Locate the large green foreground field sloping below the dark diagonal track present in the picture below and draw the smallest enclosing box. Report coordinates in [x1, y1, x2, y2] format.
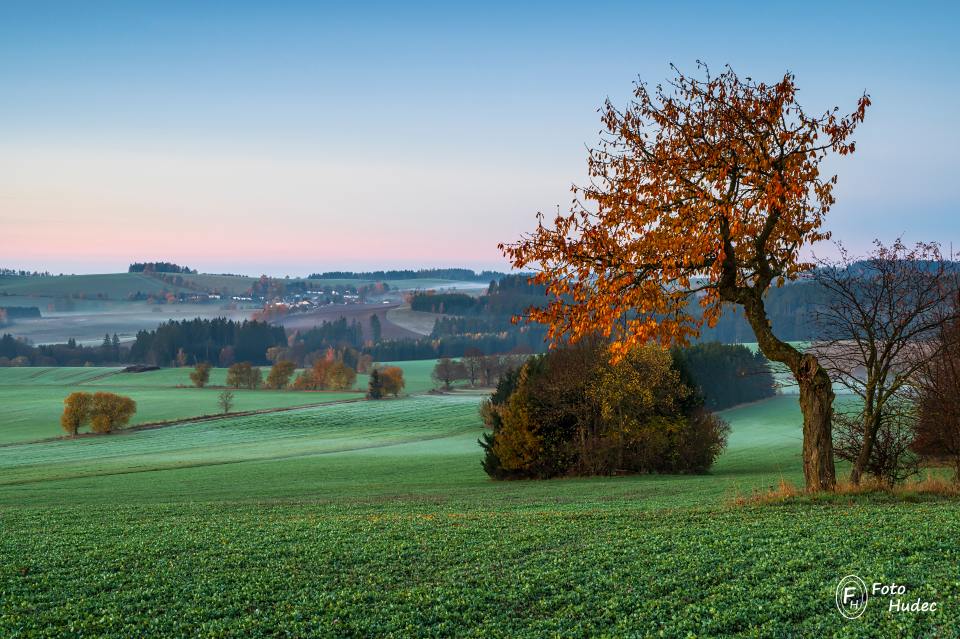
[0, 394, 960, 637]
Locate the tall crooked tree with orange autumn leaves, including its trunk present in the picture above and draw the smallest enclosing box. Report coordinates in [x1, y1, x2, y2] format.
[500, 64, 870, 490]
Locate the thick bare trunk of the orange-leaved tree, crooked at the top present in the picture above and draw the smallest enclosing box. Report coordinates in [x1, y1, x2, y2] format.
[741, 297, 837, 492]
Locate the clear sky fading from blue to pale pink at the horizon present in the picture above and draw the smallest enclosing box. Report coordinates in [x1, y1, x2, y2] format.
[0, 0, 960, 276]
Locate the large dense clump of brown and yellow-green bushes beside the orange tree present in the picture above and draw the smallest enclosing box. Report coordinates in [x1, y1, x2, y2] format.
[480, 342, 729, 479]
